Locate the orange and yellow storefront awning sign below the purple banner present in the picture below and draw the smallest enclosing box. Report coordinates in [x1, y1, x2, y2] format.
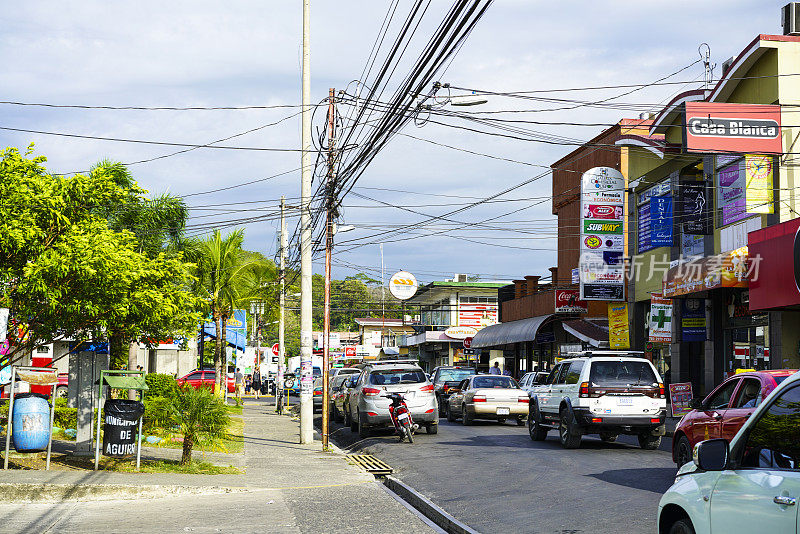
[663, 247, 750, 298]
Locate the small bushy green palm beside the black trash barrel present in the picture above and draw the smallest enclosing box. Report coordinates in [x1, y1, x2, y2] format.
[169, 384, 230, 465]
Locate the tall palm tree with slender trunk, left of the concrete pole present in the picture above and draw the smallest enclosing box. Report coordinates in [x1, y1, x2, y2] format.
[187, 230, 258, 395]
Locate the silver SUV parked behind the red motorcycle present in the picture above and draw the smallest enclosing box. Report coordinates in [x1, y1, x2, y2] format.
[345, 361, 439, 438]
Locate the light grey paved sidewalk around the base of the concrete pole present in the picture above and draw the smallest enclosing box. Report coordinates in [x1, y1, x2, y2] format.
[0, 402, 431, 534]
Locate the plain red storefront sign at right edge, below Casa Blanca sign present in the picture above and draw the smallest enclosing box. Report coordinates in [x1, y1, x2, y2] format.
[747, 219, 800, 311]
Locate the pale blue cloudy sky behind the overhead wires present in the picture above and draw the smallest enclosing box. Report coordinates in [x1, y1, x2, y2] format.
[0, 0, 786, 282]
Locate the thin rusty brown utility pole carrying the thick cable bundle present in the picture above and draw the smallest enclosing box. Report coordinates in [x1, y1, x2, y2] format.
[322, 88, 336, 451]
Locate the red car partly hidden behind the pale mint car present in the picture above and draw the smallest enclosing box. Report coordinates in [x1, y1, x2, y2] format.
[672, 369, 797, 467]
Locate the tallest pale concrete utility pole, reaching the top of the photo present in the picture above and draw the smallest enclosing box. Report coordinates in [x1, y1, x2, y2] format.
[300, 0, 314, 444]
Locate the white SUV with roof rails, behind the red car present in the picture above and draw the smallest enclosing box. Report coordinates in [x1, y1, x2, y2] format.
[528, 351, 667, 450]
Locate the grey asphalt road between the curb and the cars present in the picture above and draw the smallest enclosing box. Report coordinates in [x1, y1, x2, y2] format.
[317, 418, 676, 534]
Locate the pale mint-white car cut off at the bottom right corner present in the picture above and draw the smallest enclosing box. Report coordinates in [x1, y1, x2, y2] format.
[658, 373, 800, 534]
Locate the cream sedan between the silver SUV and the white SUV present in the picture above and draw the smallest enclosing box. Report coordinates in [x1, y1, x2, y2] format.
[447, 375, 528, 426]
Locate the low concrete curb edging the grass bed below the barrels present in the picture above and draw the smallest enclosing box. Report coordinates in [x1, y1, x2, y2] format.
[0, 482, 248, 504]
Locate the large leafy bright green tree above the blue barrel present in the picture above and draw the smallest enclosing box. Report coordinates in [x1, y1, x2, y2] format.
[0, 147, 197, 363]
